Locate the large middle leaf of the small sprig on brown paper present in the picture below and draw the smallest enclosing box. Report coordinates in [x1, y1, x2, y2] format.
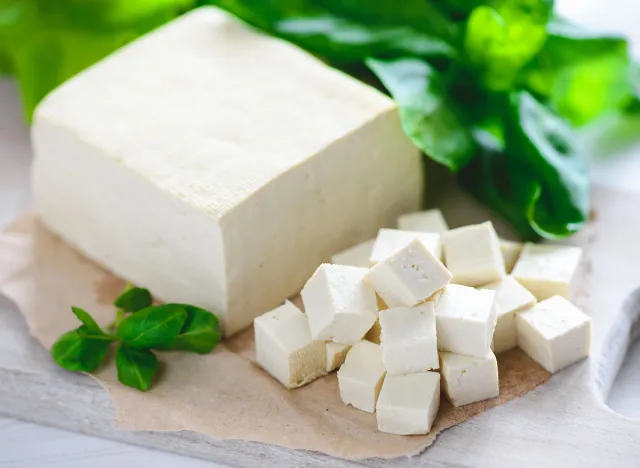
[117, 304, 187, 349]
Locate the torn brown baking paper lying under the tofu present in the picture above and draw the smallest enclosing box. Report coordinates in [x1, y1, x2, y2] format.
[0, 215, 549, 459]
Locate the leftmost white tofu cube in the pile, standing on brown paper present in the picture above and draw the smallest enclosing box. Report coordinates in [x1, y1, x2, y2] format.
[253, 301, 327, 388]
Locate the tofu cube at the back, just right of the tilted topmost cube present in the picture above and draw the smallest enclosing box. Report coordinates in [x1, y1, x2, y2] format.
[442, 221, 505, 287]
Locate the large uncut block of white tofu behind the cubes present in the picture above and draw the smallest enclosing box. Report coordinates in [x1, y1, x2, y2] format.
[32, 7, 422, 334]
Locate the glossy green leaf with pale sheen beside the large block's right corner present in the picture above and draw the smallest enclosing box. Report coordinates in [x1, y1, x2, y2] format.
[367, 58, 475, 171]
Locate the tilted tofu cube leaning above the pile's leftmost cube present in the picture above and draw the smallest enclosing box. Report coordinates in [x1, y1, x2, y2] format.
[300, 263, 378, 344]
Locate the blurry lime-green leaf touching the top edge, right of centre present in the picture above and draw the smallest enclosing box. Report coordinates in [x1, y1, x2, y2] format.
[464, 0, 553, 91]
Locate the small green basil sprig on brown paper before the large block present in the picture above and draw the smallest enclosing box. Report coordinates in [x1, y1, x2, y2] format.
[51, 285, 222, 391]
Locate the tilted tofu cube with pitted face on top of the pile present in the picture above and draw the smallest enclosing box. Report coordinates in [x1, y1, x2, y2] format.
[366, 239, 452, 307]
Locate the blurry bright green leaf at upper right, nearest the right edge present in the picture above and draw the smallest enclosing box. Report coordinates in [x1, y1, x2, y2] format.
[520, 21, 634, 125]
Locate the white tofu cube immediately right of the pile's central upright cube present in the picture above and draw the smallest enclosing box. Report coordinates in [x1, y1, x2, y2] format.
[436, 284, 496, 358]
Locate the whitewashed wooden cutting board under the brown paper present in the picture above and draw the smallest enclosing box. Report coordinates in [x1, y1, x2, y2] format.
[0, 176, 640, 467]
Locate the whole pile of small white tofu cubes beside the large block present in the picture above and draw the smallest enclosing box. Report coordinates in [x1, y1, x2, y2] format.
[254, 210, 590, 434]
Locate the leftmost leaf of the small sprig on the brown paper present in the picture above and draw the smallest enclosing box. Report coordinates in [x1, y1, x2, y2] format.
[51, 327, 111, 372]
